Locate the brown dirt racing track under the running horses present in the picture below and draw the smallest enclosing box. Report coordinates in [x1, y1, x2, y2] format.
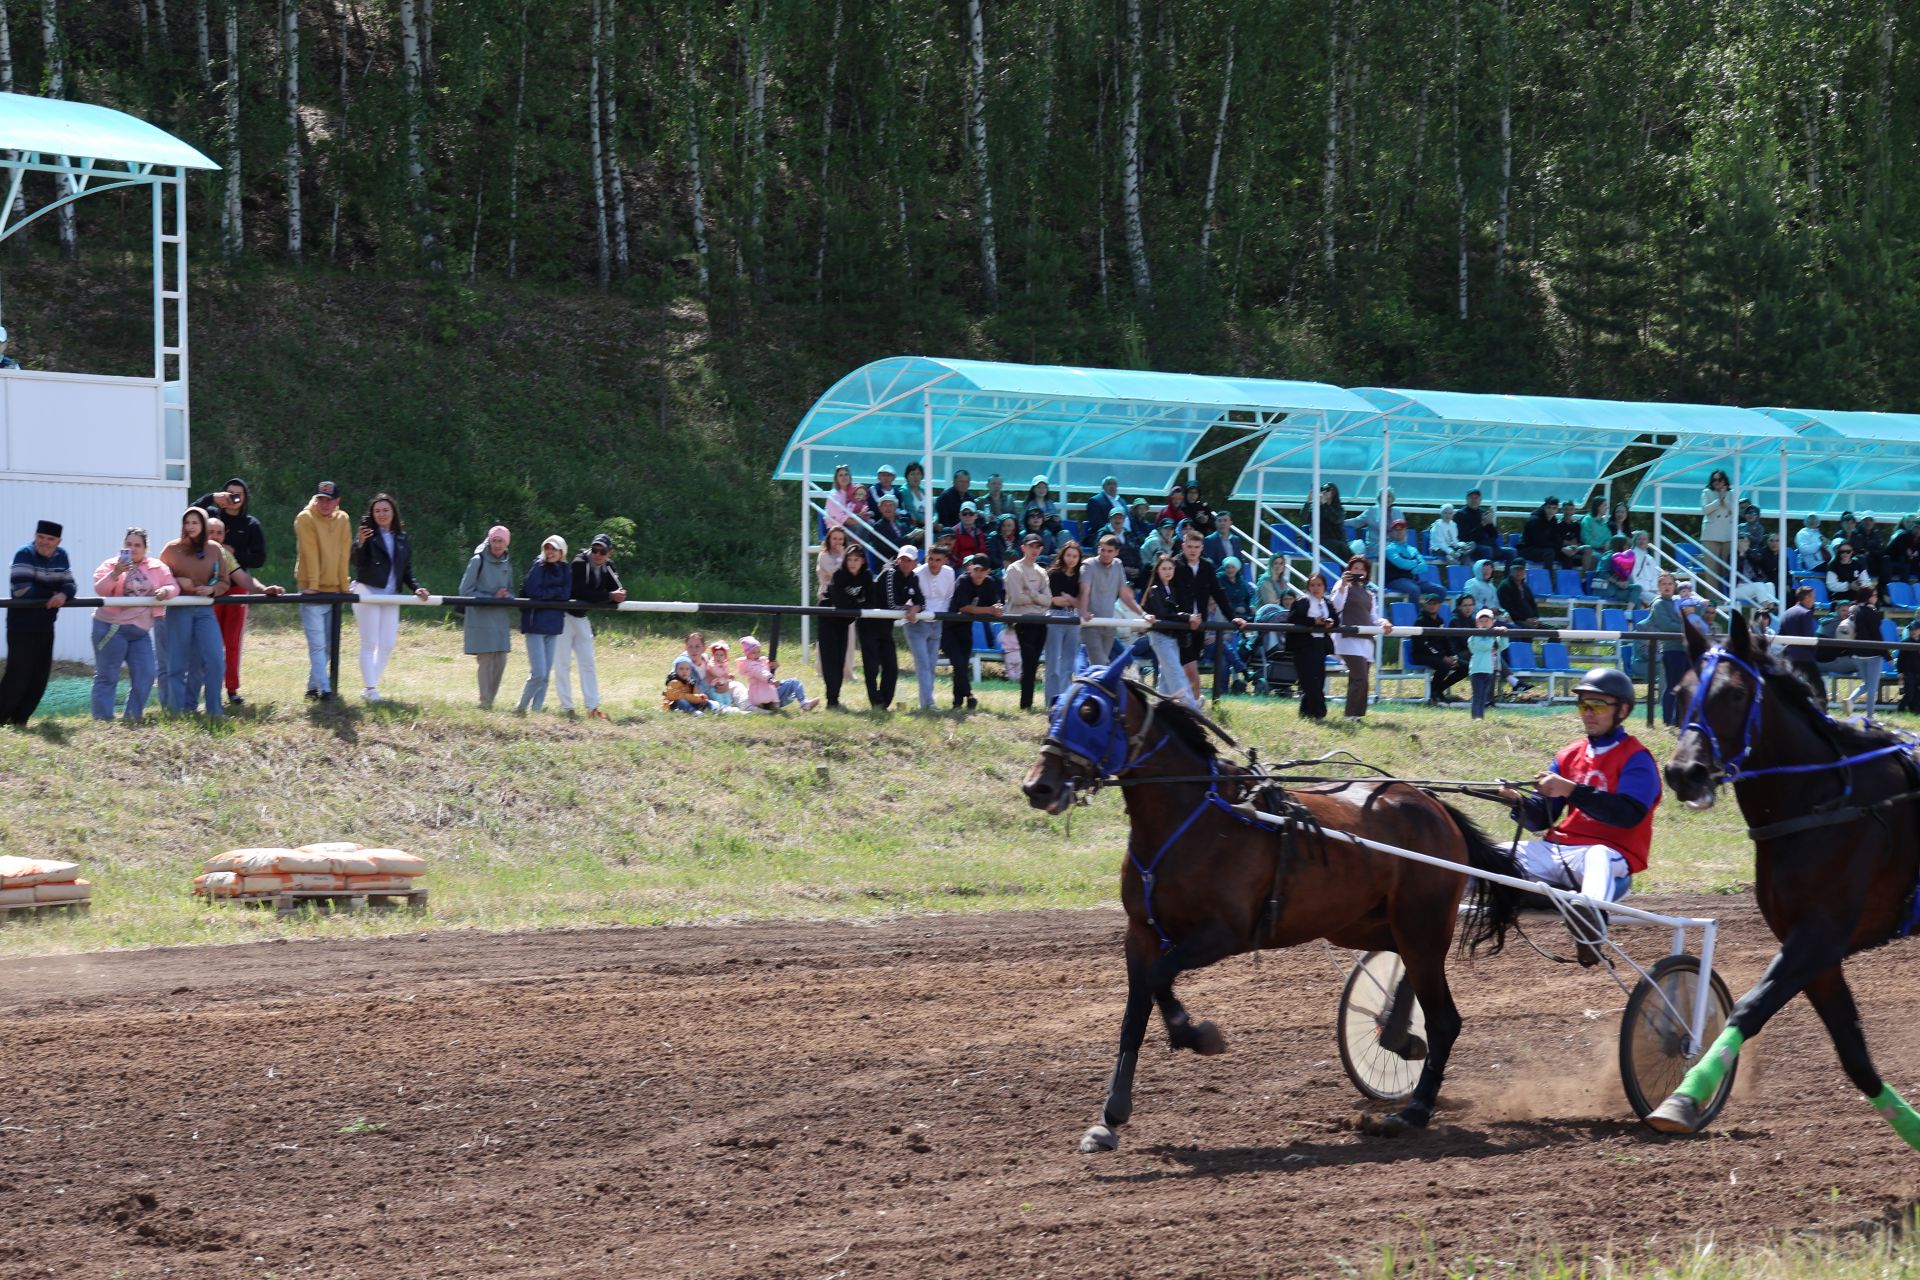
[0, 898, 1920, 1278]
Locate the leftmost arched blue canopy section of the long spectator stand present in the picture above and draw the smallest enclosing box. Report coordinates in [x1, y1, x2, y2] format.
[774, 355, 1369, 497]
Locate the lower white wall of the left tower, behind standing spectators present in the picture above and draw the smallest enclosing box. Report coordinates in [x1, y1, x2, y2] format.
[0, 474, 192, 664]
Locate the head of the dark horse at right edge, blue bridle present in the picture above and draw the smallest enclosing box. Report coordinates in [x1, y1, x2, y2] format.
[1667, 612, 1766, 810]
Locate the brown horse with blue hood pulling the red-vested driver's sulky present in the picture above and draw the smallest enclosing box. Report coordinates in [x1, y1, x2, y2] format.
[1023, 656, 1526, 1151]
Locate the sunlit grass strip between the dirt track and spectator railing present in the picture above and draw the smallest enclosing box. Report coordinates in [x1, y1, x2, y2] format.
[0, 610, 1774, 954]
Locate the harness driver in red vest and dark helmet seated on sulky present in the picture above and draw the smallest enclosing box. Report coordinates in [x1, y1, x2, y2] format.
[1500, 666, 1661, 948]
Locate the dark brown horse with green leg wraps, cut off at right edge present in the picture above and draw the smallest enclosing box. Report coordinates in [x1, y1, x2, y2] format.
[1647, 614, 1920, 1148]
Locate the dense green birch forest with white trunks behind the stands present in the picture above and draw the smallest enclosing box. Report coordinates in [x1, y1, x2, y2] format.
[0, 0, 1920, 411]
